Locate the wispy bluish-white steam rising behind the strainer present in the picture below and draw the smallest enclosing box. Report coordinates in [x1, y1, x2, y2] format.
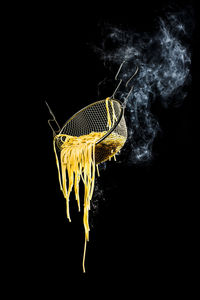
[95, 11, 193, 163]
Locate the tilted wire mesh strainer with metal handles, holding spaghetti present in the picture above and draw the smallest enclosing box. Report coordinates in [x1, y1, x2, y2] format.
[47, 61, 138, 164]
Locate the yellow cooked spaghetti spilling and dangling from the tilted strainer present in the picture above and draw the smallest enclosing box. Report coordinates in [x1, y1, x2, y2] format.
[53, 98, 126, 272]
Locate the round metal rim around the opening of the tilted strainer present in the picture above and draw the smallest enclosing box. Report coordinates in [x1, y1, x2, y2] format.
[60, 99, 125, 145]
